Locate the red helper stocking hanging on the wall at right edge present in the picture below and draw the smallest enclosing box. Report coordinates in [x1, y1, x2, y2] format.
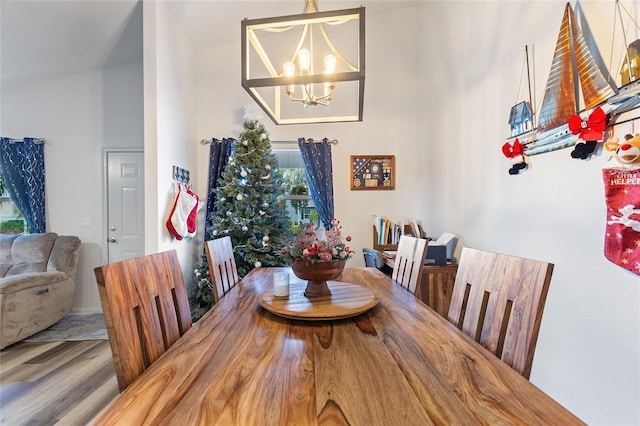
[602, 169, 640, 275]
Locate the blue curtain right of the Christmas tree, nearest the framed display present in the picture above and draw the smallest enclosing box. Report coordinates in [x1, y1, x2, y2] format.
[298, 138, 333, 229]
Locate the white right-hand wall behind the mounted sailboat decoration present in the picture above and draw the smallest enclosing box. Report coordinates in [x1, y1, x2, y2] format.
[417, 1, 640, 425]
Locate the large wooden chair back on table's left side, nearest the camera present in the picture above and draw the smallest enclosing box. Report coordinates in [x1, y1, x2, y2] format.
[94, 250, 191, 392]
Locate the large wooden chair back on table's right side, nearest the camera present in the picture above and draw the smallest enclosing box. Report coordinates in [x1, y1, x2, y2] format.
[448, 247, 553, 379]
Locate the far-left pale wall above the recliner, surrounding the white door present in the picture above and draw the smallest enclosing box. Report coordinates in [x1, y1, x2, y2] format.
[0, 62, 142, 313]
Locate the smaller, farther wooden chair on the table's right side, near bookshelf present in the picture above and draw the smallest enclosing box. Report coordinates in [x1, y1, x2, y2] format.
[391, 235, 427, 294]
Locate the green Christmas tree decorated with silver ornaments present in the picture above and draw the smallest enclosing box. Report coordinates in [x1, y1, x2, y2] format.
[210, 119, 289, 277]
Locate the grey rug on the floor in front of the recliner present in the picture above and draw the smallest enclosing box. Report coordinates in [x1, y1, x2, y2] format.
[24, 314, 109, 342]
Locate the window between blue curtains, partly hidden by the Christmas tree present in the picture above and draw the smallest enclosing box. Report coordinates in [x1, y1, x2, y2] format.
[273, 150, 319, 226]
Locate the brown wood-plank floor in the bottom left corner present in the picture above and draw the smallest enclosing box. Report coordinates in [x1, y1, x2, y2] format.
[0, 340, 118, 426]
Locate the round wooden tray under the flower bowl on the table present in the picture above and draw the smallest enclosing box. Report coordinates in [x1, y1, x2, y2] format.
[260, 281, 378, 321]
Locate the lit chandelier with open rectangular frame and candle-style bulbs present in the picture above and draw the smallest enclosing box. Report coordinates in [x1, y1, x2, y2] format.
[242, 0, 365, 124]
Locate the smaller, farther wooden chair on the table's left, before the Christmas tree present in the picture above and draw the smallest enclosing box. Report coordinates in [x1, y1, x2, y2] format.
[204, 237, 240, 302]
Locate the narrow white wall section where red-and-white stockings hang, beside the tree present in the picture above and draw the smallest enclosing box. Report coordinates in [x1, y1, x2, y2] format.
[143, 2, 199, 286]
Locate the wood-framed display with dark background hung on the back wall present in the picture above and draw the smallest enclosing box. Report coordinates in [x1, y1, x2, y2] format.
[351, 155, 396, 190]
